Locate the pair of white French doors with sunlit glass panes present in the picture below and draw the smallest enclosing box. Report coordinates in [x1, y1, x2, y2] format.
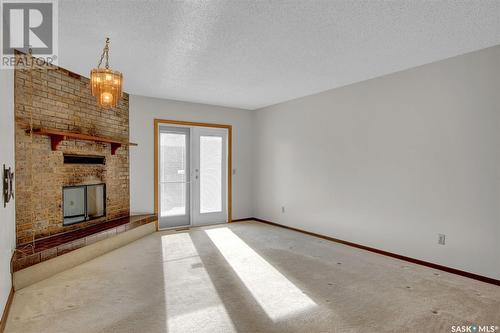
[156, 123, 228, 229]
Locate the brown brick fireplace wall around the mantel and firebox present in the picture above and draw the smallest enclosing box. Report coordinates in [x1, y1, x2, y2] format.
[15, 63, 130, 245]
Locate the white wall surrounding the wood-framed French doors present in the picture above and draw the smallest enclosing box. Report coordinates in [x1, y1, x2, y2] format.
[130, 95, 253, 219]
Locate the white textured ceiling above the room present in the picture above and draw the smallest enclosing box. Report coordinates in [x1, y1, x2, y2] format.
[59, 0, 500, 109]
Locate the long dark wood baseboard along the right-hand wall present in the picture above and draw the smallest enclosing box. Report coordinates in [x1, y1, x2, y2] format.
[253, 217, 500, 286]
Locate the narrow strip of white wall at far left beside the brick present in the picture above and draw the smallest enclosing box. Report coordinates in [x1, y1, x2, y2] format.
[0, 70, 16, 316]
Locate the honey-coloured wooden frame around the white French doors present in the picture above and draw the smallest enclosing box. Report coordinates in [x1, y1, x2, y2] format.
[154, 118, 233, 231]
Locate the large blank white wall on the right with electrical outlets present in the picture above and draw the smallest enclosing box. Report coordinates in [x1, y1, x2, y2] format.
[254, 47, 500, 279]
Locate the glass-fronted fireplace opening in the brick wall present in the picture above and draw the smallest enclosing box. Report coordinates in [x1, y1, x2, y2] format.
[63, 184, 106, 225]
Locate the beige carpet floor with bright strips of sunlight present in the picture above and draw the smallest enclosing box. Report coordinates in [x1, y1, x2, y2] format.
[6, 222, 500, 333]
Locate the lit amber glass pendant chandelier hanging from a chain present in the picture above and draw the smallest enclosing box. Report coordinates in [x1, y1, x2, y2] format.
[90, 38, 123, 108]
